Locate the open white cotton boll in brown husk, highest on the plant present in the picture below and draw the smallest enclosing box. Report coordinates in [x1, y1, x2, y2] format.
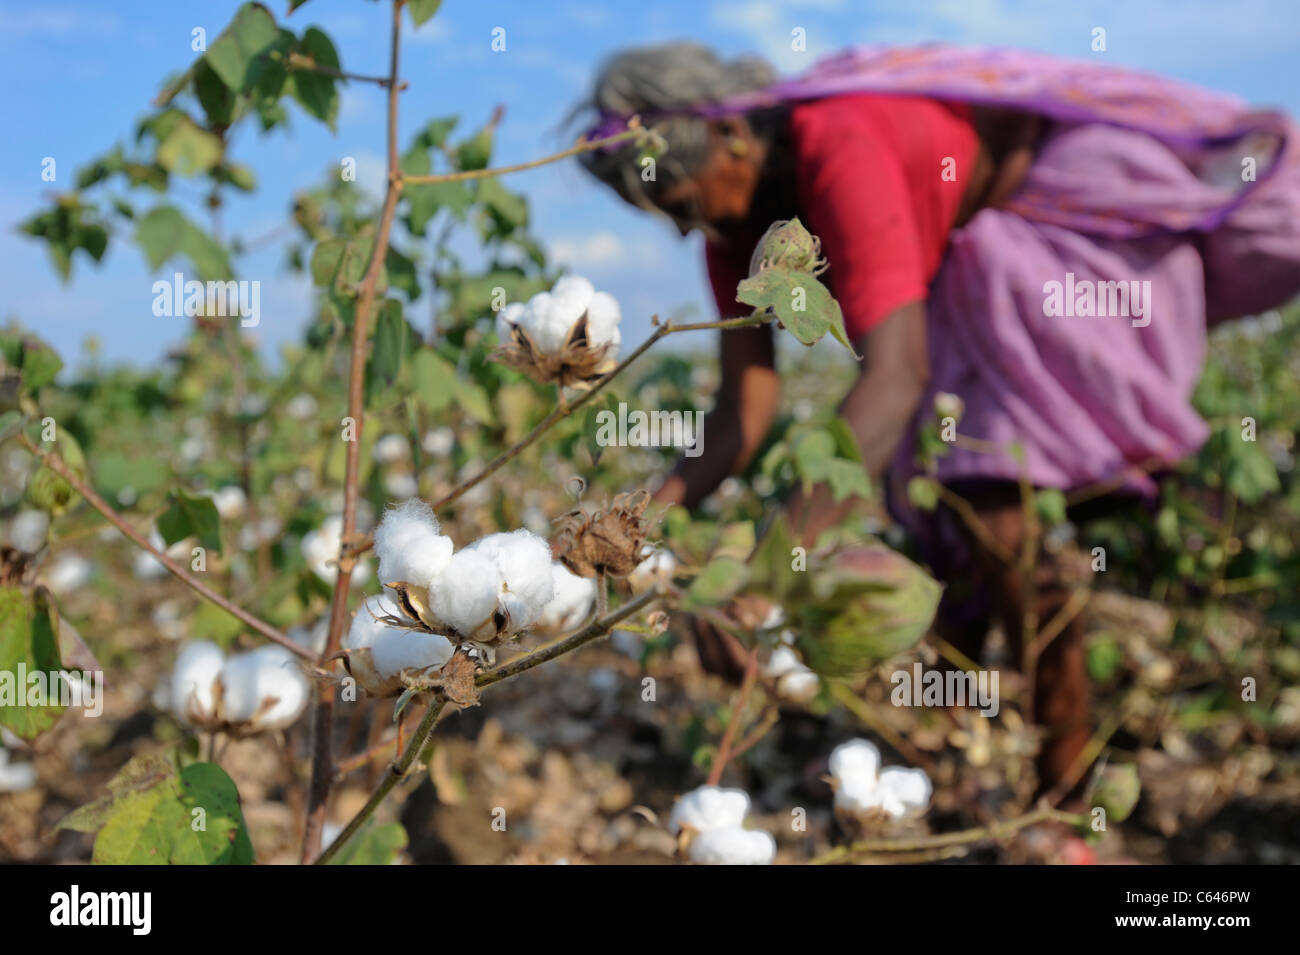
[495, 275, 623, 388]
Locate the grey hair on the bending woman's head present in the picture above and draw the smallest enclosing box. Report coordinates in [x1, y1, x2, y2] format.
[571, 43, 776, 218]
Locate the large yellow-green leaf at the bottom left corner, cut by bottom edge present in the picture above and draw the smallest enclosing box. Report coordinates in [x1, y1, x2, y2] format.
[91, 763, 254, 865]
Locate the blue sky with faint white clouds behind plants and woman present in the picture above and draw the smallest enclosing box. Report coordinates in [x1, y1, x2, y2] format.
[0, 0, 1300, 363]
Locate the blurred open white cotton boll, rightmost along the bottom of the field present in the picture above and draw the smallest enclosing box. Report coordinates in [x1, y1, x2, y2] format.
[829, 739, 933, 828]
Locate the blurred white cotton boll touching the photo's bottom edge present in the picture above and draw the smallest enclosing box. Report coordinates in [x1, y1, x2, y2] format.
[668, 786, 776, 865]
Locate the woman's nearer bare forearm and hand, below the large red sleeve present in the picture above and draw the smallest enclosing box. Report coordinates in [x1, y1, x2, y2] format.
[788, 301, 930, 546]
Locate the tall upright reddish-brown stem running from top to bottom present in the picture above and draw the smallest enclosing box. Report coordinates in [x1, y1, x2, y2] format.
[302, 0, 403, 863]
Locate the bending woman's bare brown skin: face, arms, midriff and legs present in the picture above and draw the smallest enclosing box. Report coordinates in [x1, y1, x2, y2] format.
[639, 109, 1089, 791]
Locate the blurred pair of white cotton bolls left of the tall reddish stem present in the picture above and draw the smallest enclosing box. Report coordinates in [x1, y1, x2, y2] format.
[163, 641, 311, 737]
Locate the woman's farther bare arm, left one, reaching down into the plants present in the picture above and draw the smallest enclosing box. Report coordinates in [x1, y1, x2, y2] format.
[654, 325, 781, 508]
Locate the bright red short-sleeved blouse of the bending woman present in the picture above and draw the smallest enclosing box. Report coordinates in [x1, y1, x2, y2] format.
[705, 94, 979, 338]
